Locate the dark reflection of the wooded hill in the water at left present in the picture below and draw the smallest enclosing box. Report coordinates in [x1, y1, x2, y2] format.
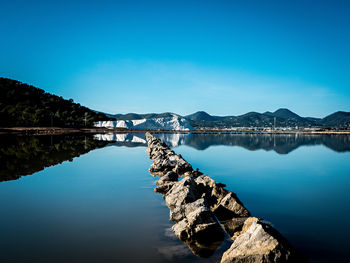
[0, 135, 107, 182]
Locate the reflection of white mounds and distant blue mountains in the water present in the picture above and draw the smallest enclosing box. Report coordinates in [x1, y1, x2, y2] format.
[95, 133, 350, 154]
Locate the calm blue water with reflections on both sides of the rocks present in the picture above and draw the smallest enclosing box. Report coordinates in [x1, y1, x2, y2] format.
[0, 133, 350, 263]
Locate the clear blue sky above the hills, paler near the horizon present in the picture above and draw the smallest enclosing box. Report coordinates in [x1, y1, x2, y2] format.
[0, 0, 350, 117]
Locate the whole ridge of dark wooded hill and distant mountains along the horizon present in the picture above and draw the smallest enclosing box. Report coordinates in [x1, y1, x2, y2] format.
[0, 77, 350, 129]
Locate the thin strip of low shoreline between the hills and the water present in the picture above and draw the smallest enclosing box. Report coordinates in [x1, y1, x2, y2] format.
[0, 127, 350, 135]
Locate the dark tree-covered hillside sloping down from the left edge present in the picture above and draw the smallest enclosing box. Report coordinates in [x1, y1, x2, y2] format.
[0, 78, 110, 127]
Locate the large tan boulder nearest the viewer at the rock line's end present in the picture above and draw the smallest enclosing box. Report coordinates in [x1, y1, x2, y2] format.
[221, 217, 305, 263]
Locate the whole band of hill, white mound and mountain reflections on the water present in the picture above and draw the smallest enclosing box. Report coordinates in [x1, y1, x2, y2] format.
[0, 133, 350, 182]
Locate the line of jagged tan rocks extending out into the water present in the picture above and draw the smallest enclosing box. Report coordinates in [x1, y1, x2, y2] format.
[146, 133, 305, 263]
